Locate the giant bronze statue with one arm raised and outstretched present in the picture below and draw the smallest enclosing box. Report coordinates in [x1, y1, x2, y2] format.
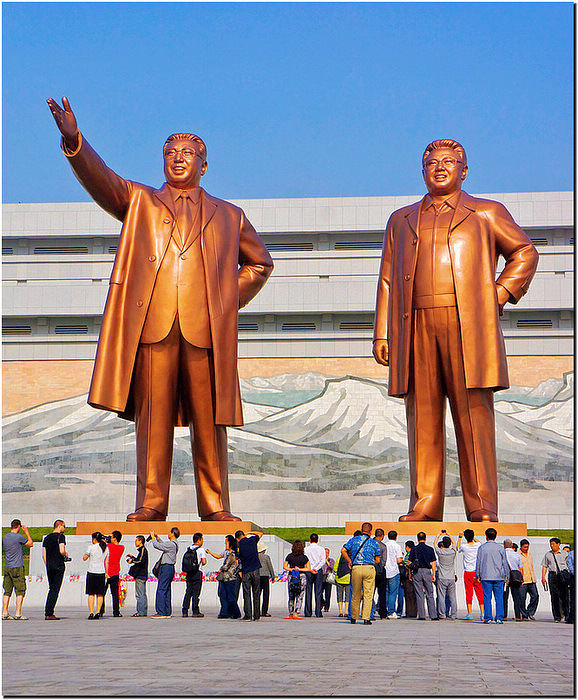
[48, 97, 273, 521]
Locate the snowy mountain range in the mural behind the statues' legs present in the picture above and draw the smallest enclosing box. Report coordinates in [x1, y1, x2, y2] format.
[3, 373, 574, 509]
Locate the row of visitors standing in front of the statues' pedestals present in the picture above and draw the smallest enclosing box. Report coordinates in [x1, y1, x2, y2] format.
[2, 519, 574, 625]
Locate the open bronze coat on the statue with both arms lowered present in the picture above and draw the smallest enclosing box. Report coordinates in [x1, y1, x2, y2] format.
[374, 192, 538, 396]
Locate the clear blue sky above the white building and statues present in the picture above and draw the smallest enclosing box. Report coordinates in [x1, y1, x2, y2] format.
[2, 2, 573, 202]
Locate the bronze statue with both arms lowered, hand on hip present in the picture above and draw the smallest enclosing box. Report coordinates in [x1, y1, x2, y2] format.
[373, 139, 538, 522]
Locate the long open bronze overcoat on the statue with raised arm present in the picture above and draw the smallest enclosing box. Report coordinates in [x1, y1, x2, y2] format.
[63, 136, 273, 425]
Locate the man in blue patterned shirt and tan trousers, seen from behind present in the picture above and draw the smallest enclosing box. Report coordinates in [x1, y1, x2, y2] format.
[341, 523, 381, 625]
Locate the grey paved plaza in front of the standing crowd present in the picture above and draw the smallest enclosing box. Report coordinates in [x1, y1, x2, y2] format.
[2, 599, 574, 697]
